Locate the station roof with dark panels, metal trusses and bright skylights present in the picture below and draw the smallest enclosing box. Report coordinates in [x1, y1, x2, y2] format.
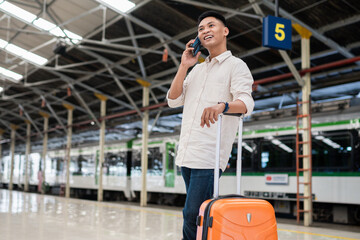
[0, 0, 360, 147]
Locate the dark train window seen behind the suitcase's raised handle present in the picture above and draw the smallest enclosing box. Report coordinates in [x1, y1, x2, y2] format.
[226, 141, 256, 173]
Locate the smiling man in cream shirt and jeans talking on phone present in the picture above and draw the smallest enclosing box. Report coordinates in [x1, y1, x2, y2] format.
[167, 11, 254, 240]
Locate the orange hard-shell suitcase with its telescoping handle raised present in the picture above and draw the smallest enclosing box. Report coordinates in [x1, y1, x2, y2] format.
[196, 114, 278, 240]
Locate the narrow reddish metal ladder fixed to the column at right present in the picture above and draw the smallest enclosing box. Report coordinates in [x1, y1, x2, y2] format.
[296, 100, 312, 223]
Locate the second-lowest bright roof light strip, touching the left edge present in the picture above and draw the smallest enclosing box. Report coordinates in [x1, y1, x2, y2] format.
[0, 39, 48, 66]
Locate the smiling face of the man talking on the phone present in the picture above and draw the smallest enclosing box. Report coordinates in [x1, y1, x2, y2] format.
[198, 17, 229, 48]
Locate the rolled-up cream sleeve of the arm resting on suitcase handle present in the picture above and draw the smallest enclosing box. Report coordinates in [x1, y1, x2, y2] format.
[230, 59, 255, 116]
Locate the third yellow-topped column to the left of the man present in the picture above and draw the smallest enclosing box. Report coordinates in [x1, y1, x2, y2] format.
[63, 103, 74, 198]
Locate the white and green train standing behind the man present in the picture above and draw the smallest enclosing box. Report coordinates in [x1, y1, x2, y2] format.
[0, 109, 360, 224]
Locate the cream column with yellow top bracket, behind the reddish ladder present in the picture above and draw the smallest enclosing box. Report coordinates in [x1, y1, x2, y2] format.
[293, 24, 312, 226]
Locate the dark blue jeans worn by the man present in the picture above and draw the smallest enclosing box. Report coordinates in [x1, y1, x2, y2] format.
[181, 167, 222, 240]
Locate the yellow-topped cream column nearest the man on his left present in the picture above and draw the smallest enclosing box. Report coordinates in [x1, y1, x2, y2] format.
[140, 82, 150, 207]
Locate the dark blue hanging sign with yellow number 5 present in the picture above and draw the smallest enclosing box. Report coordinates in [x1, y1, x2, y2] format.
[263, 16, 292, 50]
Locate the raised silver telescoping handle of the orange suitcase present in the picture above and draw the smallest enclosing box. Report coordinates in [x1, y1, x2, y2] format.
[214, 113, 244, 198]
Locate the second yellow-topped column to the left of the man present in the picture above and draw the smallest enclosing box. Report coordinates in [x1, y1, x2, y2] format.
[95, 93, 107, 202]
